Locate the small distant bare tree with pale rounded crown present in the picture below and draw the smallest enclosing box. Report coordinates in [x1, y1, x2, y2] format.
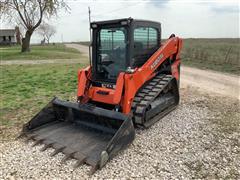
[38, 23, 57, 44]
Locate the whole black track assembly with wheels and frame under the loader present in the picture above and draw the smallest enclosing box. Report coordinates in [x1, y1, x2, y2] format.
[132, 74, 179, 127]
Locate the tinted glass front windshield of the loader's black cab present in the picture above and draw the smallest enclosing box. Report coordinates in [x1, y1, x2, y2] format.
[96, 27, 127, 80]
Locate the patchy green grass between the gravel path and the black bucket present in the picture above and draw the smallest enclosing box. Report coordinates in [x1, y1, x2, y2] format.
[0, 64, 85, 132]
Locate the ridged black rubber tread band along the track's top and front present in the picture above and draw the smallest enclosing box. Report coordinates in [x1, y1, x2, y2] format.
[132, 74, 173, 126]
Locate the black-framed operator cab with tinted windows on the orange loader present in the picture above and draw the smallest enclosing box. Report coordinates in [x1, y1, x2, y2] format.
[91, 18, 161, 84]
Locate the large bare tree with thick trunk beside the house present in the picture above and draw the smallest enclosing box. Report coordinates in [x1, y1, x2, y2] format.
[0, 0, 69, 52]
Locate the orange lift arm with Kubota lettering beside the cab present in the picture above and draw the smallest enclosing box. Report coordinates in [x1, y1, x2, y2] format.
[122, 37, 182, 114]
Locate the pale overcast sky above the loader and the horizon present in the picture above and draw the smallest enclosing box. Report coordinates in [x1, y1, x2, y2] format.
[1, 0, 240, 42]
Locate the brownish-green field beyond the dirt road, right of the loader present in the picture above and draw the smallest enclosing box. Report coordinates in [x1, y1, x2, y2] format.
[80, 38, 240, 75]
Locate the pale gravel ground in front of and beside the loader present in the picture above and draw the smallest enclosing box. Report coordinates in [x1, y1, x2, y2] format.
[0, 88, 240, 179]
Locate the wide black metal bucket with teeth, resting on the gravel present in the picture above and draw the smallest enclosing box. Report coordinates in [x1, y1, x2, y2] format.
[21, 98, 135, 171]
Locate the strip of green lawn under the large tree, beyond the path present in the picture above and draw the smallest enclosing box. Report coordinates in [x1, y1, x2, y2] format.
[0, 44, 81, 61]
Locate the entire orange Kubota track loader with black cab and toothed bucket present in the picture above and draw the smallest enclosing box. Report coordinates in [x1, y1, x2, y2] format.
[21, 18, 182, 172]
